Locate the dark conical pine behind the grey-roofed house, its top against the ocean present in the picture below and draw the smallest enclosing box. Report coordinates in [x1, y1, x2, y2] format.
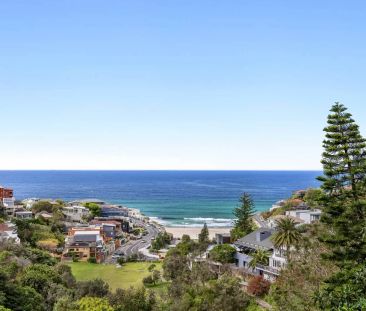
[231, 192, 254, 240]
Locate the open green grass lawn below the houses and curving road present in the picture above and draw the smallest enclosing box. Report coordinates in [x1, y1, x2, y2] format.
[69, 262, 161, 291]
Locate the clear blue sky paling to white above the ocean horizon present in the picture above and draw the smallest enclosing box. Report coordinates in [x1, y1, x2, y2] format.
[0, 0, 366, 169]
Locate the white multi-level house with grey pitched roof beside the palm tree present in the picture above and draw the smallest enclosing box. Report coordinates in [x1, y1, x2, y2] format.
[234, 228, 286, 281]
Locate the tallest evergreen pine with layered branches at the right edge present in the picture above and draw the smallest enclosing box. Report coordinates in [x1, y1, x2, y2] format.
[317, 103, 366, 310]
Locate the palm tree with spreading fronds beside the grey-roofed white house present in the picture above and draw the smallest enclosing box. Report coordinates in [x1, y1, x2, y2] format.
[272, 217, 301, 258]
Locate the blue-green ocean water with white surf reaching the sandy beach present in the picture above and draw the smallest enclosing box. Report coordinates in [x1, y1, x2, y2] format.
[0, 171, 321, 226]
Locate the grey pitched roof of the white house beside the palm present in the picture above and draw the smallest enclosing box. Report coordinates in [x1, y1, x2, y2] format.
[234, 228, 275, 250]
